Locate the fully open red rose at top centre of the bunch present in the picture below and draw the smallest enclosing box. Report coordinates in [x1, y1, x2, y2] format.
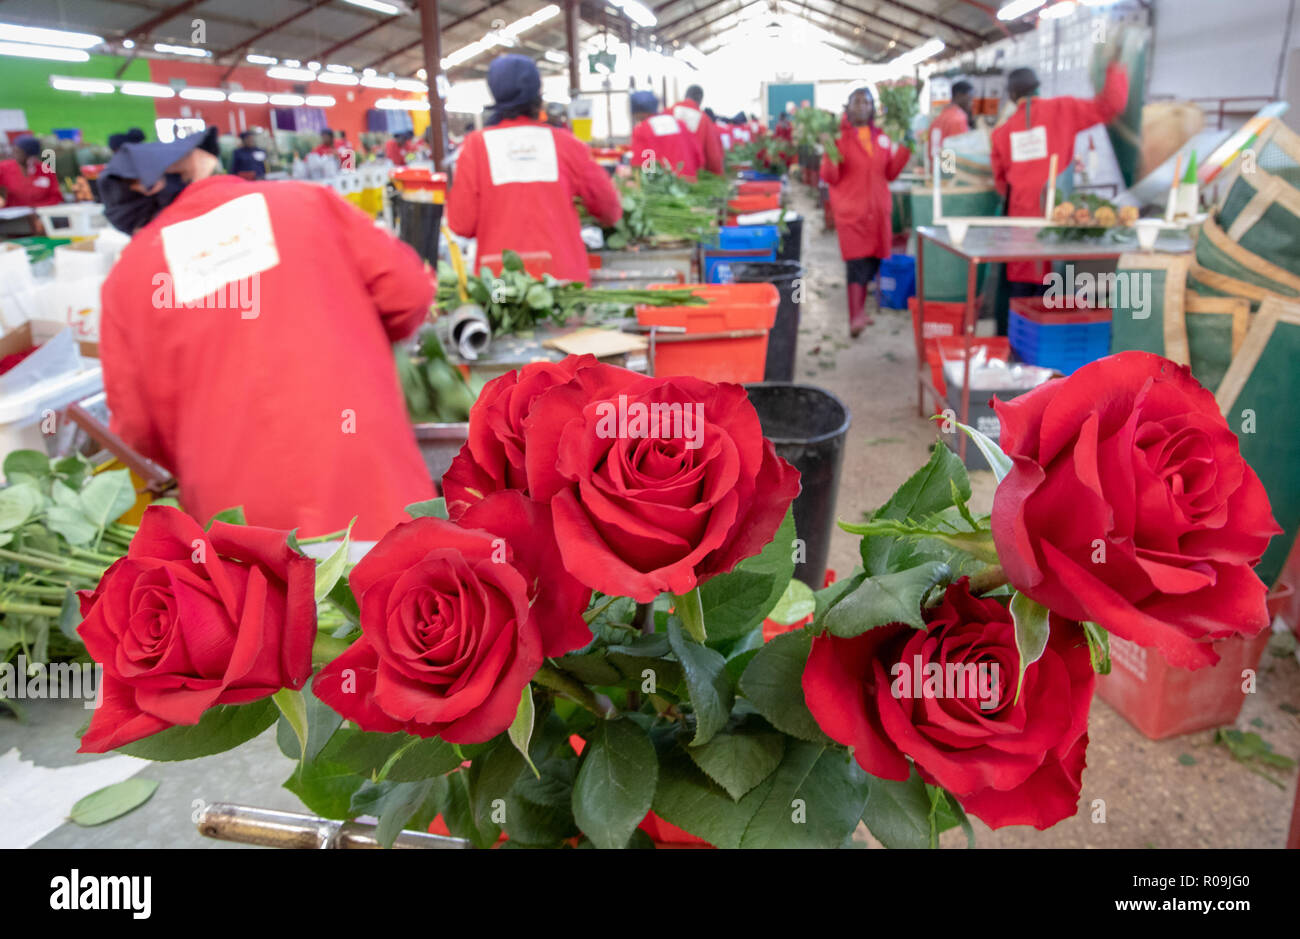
[524, 367, 800, 602]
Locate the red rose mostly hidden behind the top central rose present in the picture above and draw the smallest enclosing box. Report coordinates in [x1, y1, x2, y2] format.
[442, 355, 597, 519]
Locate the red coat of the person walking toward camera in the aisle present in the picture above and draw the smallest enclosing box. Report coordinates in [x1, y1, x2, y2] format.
[820, 116, 911, 260]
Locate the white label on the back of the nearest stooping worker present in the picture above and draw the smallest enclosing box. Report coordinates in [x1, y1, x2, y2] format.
[161, 192, 280, 304]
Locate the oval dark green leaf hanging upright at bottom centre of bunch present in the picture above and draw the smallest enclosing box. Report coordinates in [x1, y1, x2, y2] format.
[573, 717, 655, 848]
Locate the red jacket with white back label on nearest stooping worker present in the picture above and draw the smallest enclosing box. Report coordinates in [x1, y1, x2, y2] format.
[100, 176, 434, 540]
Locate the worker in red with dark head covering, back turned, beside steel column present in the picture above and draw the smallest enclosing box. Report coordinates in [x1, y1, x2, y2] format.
[447, 53, 623, 284]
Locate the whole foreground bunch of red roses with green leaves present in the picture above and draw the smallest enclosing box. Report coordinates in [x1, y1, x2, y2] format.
[79, 352, 1278, 848]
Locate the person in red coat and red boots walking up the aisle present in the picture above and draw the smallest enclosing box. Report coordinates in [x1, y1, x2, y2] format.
[820, 88, 911, 337]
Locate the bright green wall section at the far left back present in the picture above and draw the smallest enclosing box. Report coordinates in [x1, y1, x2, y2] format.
[0, 55, 156, 146]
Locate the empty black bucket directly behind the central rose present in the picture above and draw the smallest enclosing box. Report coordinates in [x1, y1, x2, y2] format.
[745, 382, 850, 590]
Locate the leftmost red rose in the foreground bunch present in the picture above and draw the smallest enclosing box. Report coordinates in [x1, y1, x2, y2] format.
[77, 506, 316, 753]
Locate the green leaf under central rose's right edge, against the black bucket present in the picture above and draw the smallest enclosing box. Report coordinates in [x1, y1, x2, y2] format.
[699, 510, 796, 642]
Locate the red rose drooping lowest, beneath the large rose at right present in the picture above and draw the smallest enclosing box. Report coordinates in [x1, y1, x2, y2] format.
[803, 577, 1096, 828]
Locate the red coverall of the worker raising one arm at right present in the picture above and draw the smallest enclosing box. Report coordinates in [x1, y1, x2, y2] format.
[993, 62, 1128, 284]
